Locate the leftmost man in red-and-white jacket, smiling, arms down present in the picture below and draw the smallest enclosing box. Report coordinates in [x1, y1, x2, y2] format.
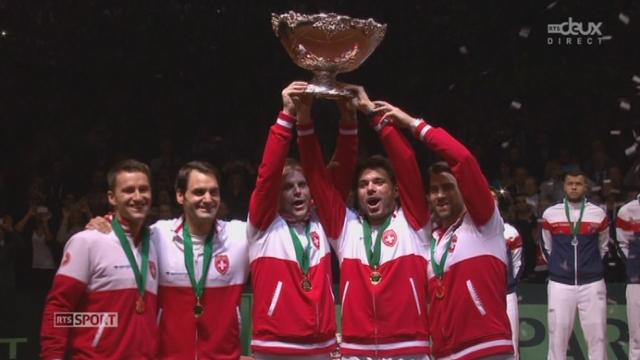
[40, 160, 158, 360]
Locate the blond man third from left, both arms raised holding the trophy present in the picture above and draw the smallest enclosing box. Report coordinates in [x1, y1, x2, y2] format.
[247, 81, 357, 359]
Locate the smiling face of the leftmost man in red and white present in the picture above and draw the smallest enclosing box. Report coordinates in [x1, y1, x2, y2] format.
[107, 171, 151, 223]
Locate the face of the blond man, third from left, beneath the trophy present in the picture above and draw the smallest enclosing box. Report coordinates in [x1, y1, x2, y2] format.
[278, 167, 311, 221]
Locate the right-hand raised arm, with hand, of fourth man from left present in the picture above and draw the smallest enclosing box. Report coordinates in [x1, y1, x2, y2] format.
[349, 90, 429, 230]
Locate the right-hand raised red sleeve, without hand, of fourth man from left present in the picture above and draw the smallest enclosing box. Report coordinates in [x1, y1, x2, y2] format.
[372, 115, 429, 230]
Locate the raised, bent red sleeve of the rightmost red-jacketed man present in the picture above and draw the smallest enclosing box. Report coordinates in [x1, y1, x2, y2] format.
[415, 123, 495, 226]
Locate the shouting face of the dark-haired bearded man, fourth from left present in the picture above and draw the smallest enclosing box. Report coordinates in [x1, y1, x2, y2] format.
[358, 168, 398, 225]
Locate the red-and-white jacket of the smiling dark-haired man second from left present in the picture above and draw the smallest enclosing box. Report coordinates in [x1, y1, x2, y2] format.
[151, 217, 249, 360]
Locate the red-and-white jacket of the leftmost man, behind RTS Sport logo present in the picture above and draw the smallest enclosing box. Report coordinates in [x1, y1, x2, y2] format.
[40, 230, 158, 360]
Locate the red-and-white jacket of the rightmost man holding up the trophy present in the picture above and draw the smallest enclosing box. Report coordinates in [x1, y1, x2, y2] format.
[414, 122, 513, 359]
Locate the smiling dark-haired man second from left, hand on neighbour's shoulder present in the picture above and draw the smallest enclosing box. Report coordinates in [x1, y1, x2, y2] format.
[87, 161, 249, 360]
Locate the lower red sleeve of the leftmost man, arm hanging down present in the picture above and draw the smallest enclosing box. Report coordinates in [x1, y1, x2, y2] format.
[40, 275, 87, 360]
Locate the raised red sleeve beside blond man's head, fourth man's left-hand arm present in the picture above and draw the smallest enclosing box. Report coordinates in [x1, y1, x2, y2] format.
[298, 129, 347, 239]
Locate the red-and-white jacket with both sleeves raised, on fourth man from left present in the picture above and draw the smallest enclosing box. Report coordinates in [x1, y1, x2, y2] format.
[299, 119, 429, 357]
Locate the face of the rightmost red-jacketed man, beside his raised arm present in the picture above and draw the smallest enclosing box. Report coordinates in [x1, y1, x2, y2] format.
[429, 172, 464, 223]
